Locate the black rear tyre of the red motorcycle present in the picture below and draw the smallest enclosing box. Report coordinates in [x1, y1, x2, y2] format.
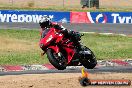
[80, 46, 97, 69]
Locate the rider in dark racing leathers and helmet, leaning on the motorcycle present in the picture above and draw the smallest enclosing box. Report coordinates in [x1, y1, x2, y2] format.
[39, 16, 81, 49]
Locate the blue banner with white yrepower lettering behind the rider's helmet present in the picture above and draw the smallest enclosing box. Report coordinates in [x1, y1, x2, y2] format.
[0, 10, 70, 23]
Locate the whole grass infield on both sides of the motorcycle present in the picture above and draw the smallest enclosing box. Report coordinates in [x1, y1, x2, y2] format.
[0, 29, 132, 65]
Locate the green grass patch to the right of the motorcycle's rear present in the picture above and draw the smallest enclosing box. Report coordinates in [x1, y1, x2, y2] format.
[83, 34, 132, 59]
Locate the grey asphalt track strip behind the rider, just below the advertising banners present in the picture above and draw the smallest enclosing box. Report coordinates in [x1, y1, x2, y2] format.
[0, 23, 132, 35]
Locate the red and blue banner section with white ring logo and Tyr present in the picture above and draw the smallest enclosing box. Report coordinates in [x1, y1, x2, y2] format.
[70, 12, 132, 24]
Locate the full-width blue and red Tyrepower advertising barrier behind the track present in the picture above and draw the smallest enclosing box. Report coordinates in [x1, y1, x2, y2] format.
[0, 10, 132, 24]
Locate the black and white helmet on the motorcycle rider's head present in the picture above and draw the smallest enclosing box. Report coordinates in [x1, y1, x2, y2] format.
[39, 16, 52, 28]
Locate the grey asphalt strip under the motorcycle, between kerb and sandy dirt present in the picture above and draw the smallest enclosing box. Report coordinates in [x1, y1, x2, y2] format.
[0, 66, 132, 76]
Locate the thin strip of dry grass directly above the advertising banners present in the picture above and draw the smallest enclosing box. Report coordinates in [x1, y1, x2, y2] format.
[0, 6, 132, 12]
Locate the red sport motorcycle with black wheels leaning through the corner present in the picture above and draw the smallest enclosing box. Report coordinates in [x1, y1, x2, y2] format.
[39, 28, 97, 70]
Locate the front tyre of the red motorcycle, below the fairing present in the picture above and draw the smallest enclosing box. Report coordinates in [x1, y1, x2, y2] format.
[47, 49, 67, 70]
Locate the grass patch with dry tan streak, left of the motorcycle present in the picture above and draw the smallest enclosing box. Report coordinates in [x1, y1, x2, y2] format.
[0, 30, 48, 65]
